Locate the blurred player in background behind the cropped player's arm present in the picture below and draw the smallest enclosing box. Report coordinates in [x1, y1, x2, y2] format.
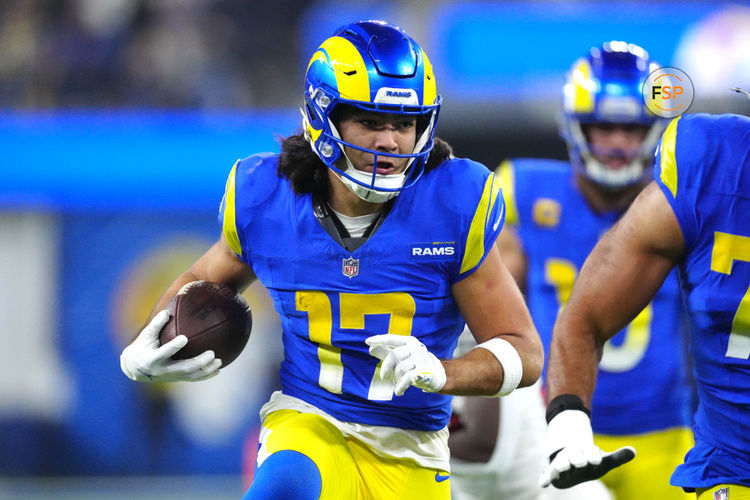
[470, 42, 692, 500]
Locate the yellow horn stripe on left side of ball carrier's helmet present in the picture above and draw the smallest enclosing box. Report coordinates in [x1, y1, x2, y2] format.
[318, 36, 370, 102]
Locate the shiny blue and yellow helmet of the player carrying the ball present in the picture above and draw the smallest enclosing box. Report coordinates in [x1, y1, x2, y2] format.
[302, 21, 440, 202]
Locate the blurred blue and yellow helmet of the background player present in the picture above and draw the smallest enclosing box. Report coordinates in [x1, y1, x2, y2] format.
[560, 41, 666, 190]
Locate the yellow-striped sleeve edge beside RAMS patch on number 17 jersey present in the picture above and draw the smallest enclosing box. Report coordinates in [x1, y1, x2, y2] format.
[455, 173, 505, 281]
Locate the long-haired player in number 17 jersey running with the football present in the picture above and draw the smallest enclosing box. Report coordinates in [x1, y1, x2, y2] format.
[122, 21, 543, 499]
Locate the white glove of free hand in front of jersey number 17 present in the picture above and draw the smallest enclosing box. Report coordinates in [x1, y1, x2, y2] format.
[365, 333, 445, 396]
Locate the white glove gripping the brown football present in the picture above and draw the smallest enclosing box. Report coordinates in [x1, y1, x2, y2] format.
[120, 310, 221, 382]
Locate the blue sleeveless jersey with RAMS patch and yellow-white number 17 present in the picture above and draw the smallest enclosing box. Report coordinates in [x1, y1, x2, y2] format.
[220, 154, 505, 430]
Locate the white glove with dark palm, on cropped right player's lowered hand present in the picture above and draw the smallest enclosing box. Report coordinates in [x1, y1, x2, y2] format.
[539, 410, 635, 489]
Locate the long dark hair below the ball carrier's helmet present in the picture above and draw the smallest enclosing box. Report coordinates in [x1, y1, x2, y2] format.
[278, 132, 453, 199]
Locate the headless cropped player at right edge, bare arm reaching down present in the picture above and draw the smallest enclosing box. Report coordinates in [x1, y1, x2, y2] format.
[540, 109, 750, 500]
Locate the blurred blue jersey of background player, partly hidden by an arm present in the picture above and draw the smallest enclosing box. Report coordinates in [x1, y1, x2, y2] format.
[498, 159, 690, 435]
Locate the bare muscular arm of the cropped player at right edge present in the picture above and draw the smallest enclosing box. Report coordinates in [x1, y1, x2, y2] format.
[547, 186, 682, 404]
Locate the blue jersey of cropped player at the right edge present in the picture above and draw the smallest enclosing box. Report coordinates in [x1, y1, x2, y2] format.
[655, 114, 750, 488]
